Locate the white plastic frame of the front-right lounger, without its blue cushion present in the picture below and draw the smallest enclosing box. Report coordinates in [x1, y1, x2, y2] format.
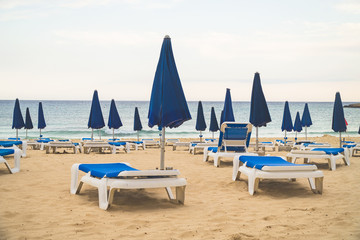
[232, 156, 324, 195]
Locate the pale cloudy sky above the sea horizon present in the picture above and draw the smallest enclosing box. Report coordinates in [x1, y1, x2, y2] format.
[0, 0, 360, 102]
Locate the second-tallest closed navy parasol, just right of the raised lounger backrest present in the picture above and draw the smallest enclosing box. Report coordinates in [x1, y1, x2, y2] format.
[249, 72, 271, 151]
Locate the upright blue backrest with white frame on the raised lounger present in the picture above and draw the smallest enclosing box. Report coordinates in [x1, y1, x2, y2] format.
[218, 122, 252, 152]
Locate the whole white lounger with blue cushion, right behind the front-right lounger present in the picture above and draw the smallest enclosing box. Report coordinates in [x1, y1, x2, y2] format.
[286, 148, 350, 171]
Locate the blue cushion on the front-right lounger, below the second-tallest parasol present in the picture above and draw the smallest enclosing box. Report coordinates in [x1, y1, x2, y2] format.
[239, 156, 306, 170]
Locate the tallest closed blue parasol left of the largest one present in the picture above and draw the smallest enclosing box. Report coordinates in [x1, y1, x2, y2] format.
[88, 90, 105, 140]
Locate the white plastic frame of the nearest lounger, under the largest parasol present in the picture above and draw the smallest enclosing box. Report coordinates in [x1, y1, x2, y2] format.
[70, 163, 187, 210]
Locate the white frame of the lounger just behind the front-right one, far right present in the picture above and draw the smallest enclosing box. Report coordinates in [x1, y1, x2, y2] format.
[286, 148, 350, 171]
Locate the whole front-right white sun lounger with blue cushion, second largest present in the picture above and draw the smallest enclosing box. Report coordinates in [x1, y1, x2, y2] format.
[232, 156, 324, 195]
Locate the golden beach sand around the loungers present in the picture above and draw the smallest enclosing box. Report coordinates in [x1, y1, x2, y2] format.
[0, 136, 360, 239]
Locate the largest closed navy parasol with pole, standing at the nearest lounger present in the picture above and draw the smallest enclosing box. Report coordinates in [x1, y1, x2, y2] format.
[148, 35, 191, 169]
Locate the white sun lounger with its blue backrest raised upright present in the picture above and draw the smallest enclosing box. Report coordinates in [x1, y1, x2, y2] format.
[203, 122, 257, 167]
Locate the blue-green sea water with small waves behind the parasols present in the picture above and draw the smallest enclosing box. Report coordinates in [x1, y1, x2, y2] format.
[0, 100, 360, 139]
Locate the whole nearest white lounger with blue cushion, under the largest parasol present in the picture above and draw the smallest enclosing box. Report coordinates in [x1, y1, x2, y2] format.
[70, 163, 186, 210]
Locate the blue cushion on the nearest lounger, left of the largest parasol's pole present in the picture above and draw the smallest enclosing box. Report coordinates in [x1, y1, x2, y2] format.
[79, 163, 139, 178]
